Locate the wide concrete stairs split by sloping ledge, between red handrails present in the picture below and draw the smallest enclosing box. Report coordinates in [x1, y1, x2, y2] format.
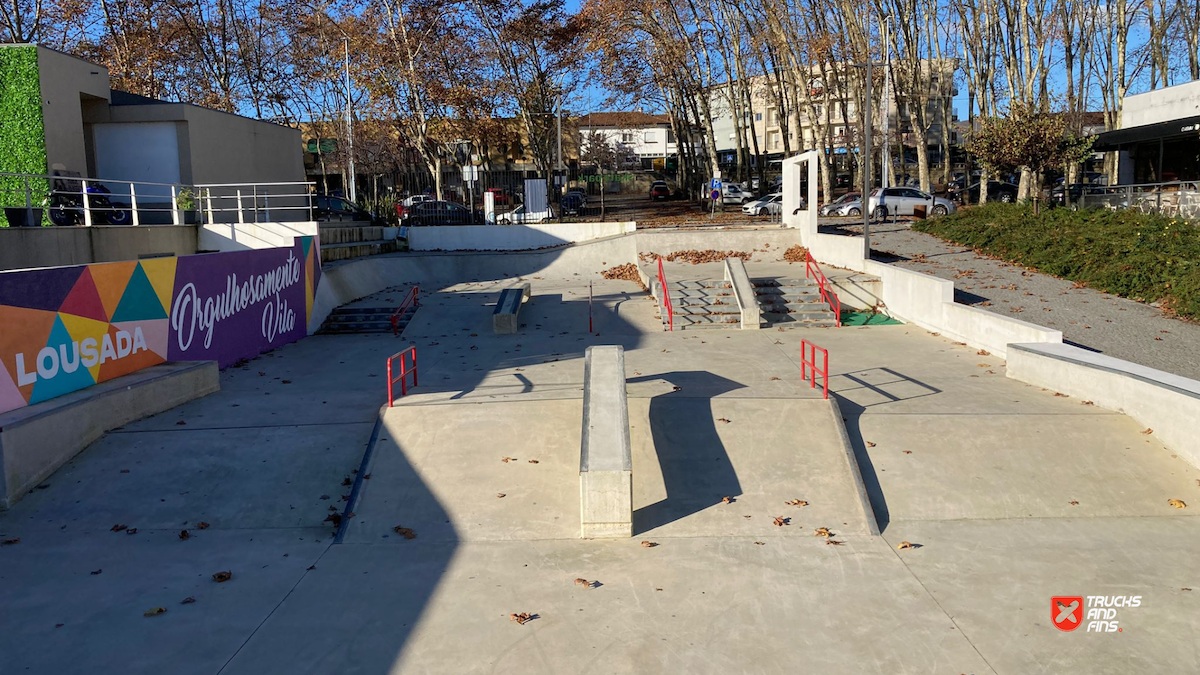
[655, 271, 838, 330]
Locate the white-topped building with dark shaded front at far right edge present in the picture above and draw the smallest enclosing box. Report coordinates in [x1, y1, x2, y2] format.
[1093, 80, 1200, 185]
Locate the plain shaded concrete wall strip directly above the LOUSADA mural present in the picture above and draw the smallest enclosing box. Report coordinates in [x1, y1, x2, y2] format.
[0, 225, 197, 270]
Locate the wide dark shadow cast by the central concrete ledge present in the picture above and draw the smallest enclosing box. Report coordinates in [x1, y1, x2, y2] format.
[626, 371, 743, 534]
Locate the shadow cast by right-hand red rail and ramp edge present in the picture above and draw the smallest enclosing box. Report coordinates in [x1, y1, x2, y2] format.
[829, 368, 942, 533]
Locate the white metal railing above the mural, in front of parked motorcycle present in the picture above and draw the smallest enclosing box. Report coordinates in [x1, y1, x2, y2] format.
[0, 172, 316, 227]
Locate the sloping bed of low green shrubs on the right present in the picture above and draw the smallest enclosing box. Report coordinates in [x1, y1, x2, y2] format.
[912, 204, 1200, 318]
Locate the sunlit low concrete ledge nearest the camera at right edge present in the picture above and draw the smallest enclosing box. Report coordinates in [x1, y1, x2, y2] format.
[1007, 344, 1200, 467]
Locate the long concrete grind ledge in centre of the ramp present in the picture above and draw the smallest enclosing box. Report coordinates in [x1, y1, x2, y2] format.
[580, 346, 634, 539]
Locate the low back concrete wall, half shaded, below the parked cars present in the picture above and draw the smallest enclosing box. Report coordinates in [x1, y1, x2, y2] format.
[408, 222, 636, 251]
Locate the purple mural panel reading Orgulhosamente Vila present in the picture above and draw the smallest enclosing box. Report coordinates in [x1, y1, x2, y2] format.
[168, 240, 307, 368]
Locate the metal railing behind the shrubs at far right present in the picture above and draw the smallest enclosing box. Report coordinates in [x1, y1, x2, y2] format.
[1065, 180, 1200, 222]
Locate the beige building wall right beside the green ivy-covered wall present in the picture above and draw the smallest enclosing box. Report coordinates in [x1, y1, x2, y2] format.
[37, 47, 109, 175]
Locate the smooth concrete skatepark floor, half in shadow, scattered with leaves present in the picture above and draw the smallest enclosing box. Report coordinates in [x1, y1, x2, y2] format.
[0, 265, 1200, 675]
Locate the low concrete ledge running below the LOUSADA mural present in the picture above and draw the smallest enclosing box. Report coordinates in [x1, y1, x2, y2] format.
[0, 362, 221, 508]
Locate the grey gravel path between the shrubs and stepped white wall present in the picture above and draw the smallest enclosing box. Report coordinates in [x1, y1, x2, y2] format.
[821, 221, 1200, 380]
